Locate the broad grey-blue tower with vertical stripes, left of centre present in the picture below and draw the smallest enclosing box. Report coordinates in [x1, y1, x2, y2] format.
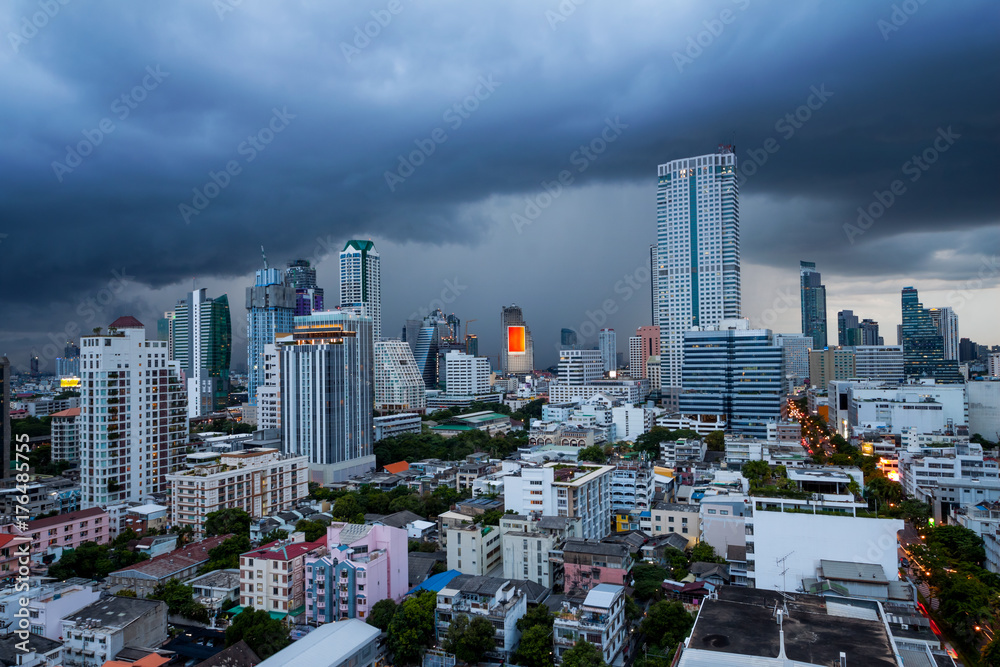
[277, 310, 375, 484]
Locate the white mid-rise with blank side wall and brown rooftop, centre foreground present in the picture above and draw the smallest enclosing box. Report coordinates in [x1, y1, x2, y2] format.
[504, 463, 614, 540]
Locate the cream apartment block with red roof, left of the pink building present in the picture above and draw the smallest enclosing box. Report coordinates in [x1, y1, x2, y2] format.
[240, 533, 326, 621]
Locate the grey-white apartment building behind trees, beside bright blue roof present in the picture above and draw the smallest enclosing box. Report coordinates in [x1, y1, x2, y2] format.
[434, 574, 528, 662]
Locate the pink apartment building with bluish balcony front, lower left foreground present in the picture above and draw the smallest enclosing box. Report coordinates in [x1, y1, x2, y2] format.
[306, 522, 409, 625]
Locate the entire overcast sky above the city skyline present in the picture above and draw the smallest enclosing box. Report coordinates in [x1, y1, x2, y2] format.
[0, 0, 1000, 371]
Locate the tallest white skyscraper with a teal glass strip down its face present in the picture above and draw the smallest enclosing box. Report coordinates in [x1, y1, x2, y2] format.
[653, 146, 741, 396]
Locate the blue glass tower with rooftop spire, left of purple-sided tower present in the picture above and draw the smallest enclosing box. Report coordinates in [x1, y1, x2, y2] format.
[247, 265, 296, 405]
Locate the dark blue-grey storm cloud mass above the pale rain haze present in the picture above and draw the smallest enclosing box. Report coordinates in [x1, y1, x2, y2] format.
[0, 0, 1000, 366]
